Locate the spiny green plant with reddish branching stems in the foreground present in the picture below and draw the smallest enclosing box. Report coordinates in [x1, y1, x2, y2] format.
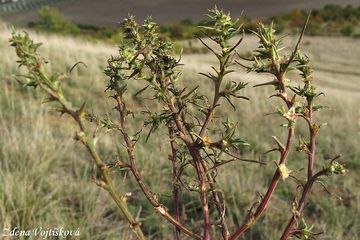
[10, 8, 346, 240]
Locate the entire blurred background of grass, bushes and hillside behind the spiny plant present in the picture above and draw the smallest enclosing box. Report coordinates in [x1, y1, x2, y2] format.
[0, 0, 360, 240]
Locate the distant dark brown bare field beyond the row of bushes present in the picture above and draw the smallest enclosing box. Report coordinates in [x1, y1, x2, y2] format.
[0, 0, 360, 27]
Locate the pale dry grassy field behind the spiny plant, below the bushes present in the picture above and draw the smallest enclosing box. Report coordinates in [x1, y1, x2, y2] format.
[0, 21, 360, 240]
